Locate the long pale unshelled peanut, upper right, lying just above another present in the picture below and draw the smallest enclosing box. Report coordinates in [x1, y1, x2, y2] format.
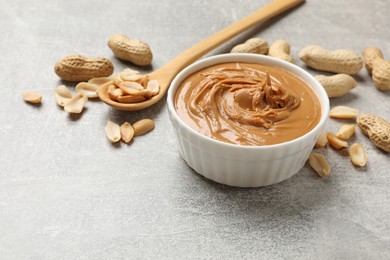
[299, 45, 363, 75]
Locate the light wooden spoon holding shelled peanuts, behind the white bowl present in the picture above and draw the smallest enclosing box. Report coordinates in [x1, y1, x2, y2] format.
[98, 0, 305, 111]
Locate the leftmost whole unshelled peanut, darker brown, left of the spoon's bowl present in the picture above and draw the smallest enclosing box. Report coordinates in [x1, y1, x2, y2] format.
[54, 55, 114, 82]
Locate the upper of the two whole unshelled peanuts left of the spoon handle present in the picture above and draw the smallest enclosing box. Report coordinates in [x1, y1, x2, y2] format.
[108, 34, 153, 66]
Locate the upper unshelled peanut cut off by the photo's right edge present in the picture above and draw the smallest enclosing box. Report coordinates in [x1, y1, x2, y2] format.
[363, 47, 390, 91]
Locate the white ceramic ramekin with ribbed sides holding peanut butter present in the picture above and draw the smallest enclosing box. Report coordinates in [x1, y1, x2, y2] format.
[167, 54, 329, 187]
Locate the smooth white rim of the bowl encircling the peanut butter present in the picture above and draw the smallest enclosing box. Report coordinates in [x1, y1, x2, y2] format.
[167, 53, 330, 150]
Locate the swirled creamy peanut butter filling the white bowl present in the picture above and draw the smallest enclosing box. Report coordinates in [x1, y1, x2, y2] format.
[175, 63, 321, 146]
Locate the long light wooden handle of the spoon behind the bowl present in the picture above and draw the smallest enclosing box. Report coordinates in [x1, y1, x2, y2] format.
[160, 0, 305, 76]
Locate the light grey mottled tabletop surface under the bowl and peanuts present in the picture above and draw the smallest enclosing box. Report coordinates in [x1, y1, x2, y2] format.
[0, 0, 390, 259]
